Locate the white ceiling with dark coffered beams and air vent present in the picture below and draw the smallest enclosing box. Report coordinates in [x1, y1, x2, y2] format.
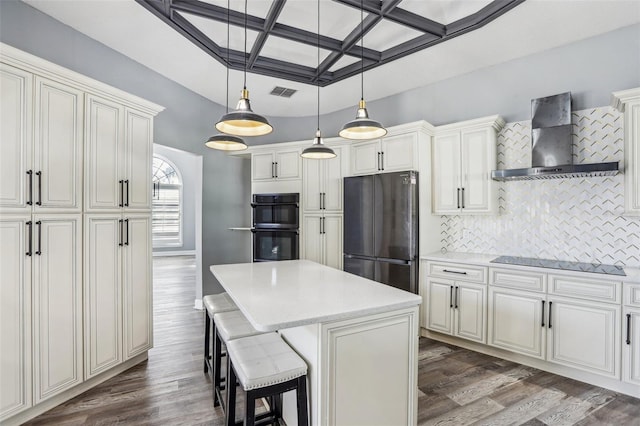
[23, 0, 640, 116]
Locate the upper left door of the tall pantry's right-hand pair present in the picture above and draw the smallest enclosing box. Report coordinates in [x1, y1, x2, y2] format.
[84, 95, 125, 211]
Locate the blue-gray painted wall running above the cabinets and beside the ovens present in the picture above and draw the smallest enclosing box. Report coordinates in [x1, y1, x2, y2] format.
[0, 0, 640, 294]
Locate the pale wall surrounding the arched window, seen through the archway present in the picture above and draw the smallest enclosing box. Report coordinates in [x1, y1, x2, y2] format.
[153, 143, 200, 253]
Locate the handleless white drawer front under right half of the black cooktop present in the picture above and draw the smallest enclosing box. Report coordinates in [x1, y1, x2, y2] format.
[549, 275, 622, 303]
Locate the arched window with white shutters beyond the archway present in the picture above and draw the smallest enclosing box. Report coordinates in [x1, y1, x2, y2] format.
[152, 154, 182, 247]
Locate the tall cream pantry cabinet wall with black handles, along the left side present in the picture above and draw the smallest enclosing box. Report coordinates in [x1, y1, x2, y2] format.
[0, 44, 162, 424]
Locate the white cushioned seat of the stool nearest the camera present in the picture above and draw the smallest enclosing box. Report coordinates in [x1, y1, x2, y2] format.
[227, 333, 307, 391]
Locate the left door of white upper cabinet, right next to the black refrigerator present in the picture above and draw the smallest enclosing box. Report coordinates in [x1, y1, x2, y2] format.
[433, 133, 461, 214]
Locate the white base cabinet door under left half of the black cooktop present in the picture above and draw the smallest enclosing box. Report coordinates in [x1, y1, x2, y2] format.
[488, 287, 546, 359]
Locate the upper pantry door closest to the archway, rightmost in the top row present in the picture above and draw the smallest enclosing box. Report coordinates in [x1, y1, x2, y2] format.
[121, 109, 153, 211]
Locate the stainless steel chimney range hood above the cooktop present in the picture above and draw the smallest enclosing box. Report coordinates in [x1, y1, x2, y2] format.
[491, 92, 618, 181]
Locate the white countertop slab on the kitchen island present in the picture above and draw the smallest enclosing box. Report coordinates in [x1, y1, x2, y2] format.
[210, 260, 422, 331]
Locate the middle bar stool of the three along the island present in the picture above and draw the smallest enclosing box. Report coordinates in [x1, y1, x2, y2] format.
[213, 310, 262, 409]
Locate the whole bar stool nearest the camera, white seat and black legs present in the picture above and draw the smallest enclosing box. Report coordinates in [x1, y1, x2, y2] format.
[225, 333, 309, 426]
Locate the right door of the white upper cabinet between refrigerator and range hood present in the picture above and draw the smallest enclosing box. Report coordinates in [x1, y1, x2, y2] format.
[461, 129, 497, 213]
